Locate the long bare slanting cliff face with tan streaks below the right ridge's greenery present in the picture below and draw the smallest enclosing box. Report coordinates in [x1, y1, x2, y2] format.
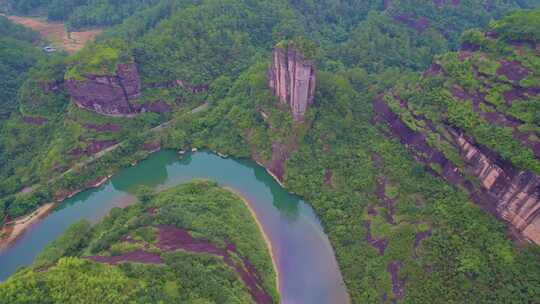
[374, 96, 540, 244]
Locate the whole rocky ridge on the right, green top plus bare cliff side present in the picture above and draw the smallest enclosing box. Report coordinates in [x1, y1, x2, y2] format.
[375, 11, 540, 244]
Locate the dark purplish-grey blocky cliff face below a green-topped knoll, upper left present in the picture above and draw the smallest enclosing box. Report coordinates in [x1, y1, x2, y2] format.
[66, 63, 141, 116]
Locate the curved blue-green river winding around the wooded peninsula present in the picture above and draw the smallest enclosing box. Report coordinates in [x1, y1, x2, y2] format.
[0, 151, 348, 304]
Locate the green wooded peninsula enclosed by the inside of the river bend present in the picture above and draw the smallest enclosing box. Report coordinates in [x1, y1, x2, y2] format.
[0, 181, 279, 304]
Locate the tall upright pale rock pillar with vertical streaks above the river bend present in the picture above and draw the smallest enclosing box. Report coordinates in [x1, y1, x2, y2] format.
[268, 46, 316, 121]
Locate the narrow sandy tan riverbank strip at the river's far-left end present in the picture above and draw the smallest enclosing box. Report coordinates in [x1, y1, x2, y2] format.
[0, 203, 56, 251]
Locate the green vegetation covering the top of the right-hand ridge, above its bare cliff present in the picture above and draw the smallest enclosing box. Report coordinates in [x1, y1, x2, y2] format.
[386, 10, 540, 174]
